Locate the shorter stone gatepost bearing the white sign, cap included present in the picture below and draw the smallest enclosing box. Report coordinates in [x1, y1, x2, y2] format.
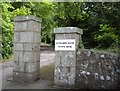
[54, 27, 83, 88]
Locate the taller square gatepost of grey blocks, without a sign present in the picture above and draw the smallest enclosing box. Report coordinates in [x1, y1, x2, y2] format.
[13, 15, 42, 82]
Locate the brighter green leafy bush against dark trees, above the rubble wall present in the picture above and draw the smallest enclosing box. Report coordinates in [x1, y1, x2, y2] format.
[95, 24, 119, 48]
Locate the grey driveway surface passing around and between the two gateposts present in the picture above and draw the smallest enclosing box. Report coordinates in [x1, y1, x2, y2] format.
[0, 50, 55, 89]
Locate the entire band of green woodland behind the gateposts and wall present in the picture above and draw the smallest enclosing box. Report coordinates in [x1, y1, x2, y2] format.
[0, 2, 120, 59]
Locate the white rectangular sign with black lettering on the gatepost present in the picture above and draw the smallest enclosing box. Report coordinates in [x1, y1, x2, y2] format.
[55, 39, 75, 51]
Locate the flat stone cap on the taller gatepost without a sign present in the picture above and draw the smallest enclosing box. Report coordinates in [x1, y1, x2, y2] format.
[14, 15, 42, 22]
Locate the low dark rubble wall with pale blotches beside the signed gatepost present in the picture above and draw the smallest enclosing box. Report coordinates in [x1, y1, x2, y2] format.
[76, 49, 120, 89]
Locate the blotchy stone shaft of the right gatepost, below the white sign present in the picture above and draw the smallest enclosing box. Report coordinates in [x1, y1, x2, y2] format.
[54, 51, 76, 87]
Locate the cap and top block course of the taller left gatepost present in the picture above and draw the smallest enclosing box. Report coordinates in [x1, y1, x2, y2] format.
[14, 15, 42, 32]
